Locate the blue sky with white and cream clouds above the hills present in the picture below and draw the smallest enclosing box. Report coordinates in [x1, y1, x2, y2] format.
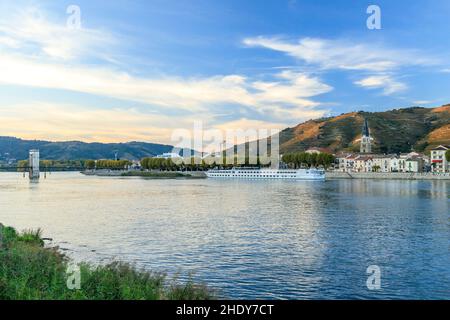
[0, 0, 450, 143]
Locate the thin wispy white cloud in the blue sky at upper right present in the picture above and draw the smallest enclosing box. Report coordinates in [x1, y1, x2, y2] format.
[243, 37, 437, 95]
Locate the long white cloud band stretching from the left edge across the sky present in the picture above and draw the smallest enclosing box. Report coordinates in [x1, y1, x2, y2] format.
[0, 54, 332, 117]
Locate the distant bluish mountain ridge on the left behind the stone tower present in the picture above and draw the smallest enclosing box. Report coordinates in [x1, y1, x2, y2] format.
[0, 137, 173, 160]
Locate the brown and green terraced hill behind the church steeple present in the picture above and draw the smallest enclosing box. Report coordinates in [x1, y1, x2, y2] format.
[280, 105, 450, 153]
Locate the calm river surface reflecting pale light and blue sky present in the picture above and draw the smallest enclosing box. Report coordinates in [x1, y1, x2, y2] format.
[0, 173, 450, 299]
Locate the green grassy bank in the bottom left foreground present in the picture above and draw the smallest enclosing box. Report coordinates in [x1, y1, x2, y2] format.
[0, 224, 213, 300]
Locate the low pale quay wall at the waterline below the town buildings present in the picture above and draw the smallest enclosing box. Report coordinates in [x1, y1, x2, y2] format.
[325, 171, 450, 180]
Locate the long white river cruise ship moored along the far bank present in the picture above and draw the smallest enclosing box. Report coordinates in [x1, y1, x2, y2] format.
[206, 168, 325, 180]
